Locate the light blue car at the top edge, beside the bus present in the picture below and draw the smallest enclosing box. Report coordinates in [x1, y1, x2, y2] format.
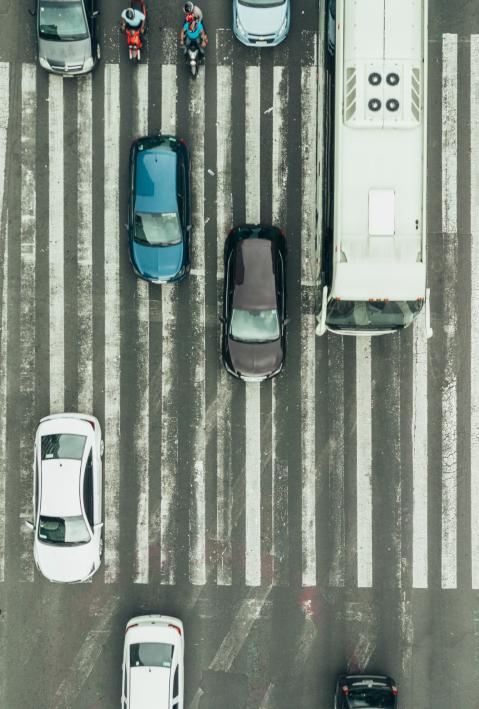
[233, 0, 290, 47]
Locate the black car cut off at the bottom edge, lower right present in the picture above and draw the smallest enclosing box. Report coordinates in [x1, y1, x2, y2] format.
[334, 674, 398, 709]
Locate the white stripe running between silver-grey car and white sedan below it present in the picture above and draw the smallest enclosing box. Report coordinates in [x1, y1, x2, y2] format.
[48, 74, 65, 414]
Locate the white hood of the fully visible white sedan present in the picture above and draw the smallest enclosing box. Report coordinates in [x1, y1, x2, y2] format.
[35, 539, 97, 583]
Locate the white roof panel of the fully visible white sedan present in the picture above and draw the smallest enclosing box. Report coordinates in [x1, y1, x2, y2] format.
[40, 458, 82, 517]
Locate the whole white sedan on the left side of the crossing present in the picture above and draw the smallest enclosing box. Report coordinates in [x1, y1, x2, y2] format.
[27, 414, 103, 583]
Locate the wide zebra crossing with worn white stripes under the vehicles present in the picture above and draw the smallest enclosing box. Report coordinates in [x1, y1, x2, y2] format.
[0, 29, 479, 589]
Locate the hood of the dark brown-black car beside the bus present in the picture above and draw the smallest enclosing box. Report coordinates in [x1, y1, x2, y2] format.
[228, 337, 283, 377]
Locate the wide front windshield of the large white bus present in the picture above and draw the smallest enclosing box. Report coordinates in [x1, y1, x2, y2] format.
[326, 299, 424, 330]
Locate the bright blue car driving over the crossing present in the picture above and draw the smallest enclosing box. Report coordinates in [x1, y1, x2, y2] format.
[128, 135, 191, 283]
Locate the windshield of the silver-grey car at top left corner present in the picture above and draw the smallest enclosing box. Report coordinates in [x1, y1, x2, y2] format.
[38, 0, 88, 41]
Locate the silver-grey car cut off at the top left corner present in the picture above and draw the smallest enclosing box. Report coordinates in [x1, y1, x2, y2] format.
[36, 0, 100, 77]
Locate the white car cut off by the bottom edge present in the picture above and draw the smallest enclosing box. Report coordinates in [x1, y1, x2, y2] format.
[121, 615, 184, 709]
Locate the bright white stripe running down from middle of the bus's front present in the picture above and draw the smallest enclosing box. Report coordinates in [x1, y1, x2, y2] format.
[356, 337, 373, 588]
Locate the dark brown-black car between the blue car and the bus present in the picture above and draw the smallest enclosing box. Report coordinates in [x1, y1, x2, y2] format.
[223, 224, 286, 381]
